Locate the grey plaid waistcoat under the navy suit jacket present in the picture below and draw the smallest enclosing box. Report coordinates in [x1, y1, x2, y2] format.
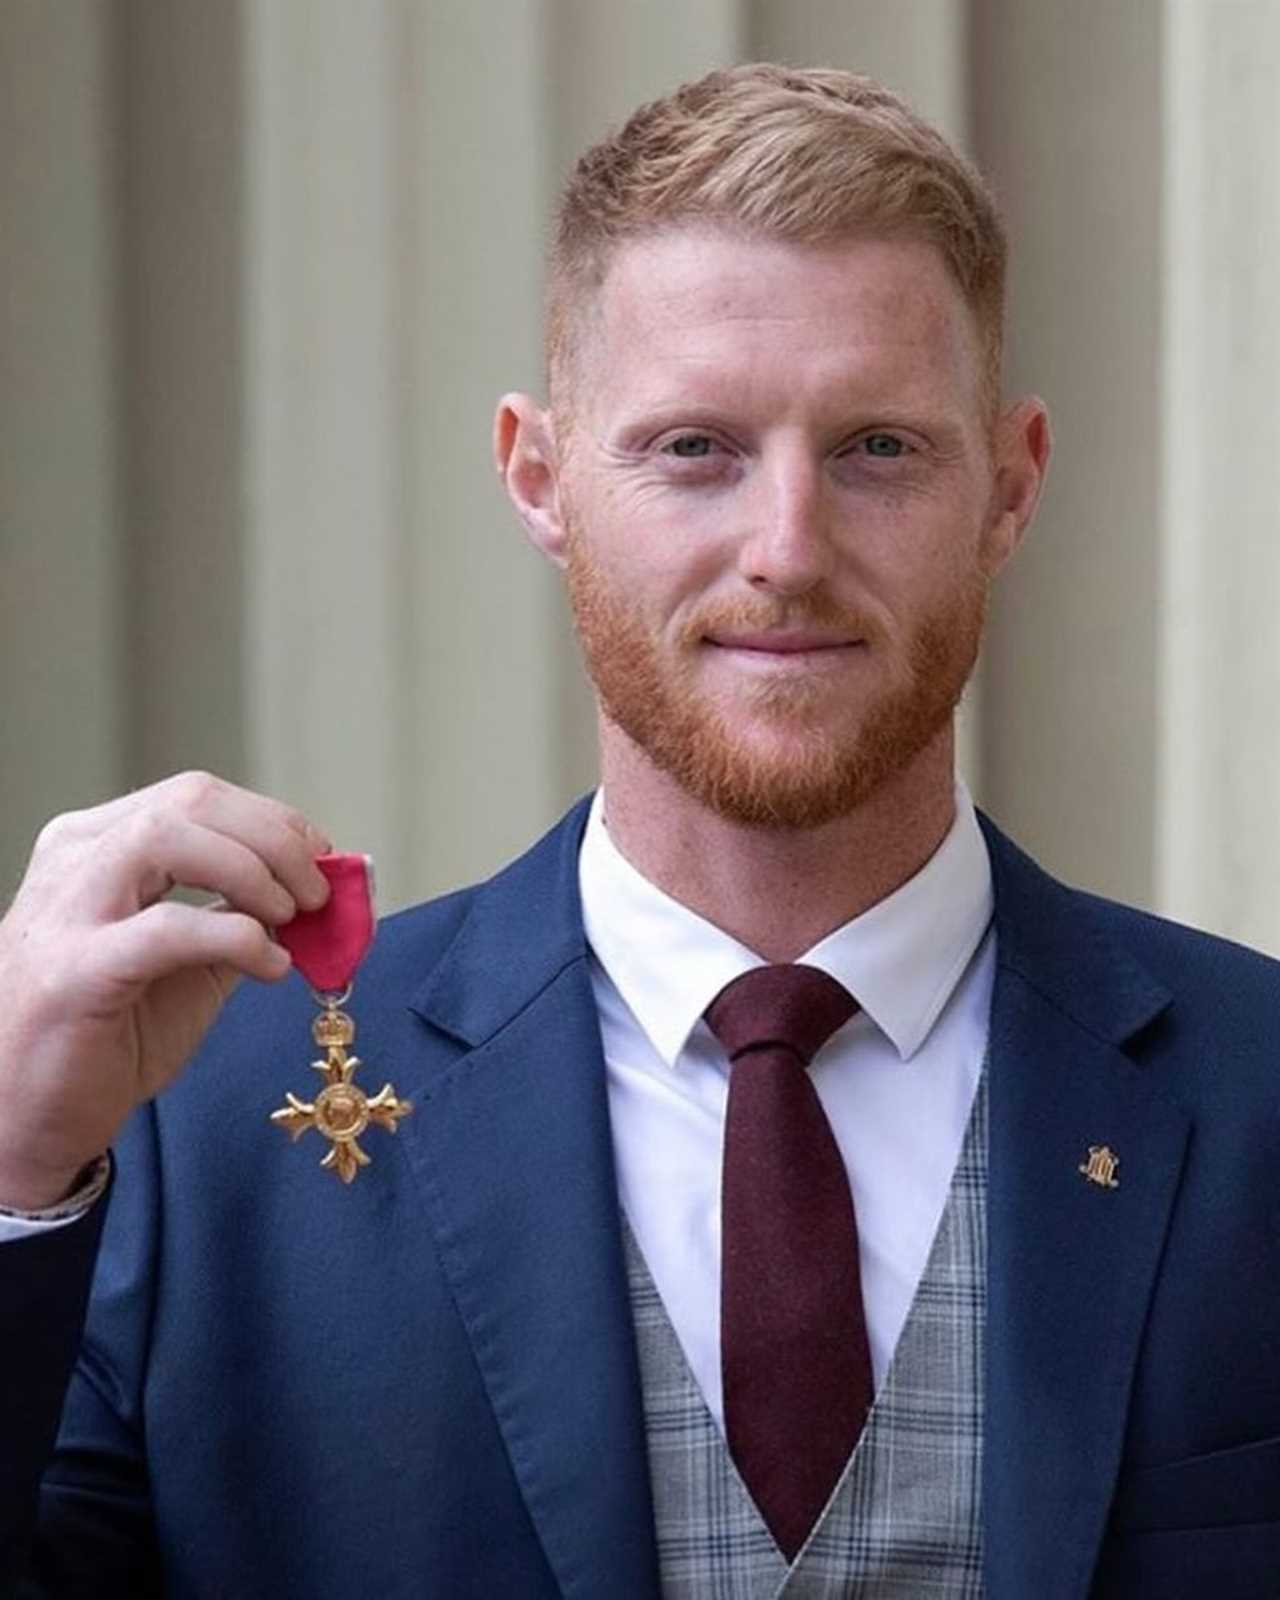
[622, 1074, 987, 1600]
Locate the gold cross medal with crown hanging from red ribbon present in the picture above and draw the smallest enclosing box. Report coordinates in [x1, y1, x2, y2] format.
[270, 853, 413, 1184]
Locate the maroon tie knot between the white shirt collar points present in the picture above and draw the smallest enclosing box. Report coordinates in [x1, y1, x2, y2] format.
[706, 963, 858, 1066]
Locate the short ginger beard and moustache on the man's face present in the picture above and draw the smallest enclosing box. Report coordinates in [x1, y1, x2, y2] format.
[566, 518, 989, 830]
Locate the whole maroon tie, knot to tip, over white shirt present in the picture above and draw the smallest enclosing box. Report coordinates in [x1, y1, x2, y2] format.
[706, 965, 872, 1560]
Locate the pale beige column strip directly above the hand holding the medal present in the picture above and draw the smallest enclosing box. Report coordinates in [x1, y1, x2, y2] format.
[242, 0, 408, 896]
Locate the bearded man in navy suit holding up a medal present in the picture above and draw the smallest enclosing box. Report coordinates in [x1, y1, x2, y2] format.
[0, 67, 1280, 1600]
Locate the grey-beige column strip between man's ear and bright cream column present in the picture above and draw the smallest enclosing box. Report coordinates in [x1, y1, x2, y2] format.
[970, 0, 1163, 904]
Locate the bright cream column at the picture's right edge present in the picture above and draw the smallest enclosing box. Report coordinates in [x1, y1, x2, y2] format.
[1154, 0, 1280, 954]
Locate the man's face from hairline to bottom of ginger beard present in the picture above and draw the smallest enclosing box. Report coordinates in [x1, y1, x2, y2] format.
[558, 229, 1011, 827]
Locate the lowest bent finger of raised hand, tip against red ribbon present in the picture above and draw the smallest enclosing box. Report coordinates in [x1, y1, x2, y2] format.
[98, 901, 291, 989]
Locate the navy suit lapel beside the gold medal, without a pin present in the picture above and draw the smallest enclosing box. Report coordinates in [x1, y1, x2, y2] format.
[403, 808, 658, 1600]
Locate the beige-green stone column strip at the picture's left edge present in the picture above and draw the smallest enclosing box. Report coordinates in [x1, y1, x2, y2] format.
[0, 0, 128, 906]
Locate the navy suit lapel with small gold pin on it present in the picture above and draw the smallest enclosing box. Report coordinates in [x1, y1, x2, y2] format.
[984, 827, 1190, 1600]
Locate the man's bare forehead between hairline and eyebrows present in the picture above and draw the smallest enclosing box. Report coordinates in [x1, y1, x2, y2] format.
[582, 227, 981, 425]
